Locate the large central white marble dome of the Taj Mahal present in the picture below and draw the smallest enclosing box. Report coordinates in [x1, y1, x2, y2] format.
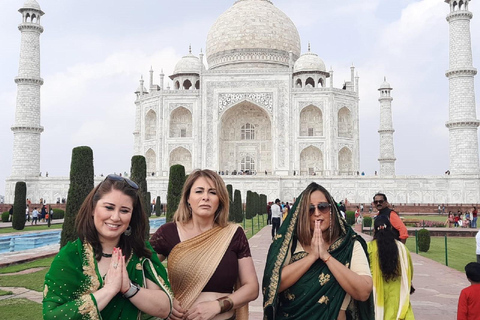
[206, 0, 301, 69]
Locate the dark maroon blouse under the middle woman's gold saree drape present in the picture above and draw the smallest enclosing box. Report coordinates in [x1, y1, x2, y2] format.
[150, 222, 252, 293]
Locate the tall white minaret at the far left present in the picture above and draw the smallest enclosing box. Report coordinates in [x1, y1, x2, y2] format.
[10, 0, 44, 179]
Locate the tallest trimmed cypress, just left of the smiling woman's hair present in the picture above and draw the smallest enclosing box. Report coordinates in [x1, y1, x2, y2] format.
[60, 146, 94, 247]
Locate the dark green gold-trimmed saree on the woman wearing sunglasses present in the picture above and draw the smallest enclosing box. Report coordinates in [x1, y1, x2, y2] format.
[262, 197, 374, 320]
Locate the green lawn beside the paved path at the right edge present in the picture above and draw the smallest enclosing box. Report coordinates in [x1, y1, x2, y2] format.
[407, 237, 477, 272]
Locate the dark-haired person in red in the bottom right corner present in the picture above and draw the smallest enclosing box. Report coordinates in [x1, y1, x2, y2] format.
[457, 262, 480, 320]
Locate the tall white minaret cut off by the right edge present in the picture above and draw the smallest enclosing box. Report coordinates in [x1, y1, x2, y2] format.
[445, 0, 480, 175]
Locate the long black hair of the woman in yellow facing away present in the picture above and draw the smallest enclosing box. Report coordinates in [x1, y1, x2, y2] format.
[373, 215, 400, 282]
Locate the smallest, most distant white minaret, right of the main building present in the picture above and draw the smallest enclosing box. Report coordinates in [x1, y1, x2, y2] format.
[378, 79, 397, 176]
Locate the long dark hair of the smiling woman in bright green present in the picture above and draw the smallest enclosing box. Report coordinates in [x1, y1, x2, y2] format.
[75, 177, 152, 261]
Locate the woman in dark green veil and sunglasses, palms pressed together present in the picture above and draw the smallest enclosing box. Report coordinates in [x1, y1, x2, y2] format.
[262, 182, 374, 320]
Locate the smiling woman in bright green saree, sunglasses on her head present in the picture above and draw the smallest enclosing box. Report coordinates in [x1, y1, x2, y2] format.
[43, 175, 173, 319]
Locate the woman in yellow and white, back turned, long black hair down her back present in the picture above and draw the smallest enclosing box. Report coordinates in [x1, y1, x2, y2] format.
[368, 216, 414, 320]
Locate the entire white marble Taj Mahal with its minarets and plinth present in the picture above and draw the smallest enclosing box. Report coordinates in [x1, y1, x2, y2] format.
[5, 0, 480, 203]
